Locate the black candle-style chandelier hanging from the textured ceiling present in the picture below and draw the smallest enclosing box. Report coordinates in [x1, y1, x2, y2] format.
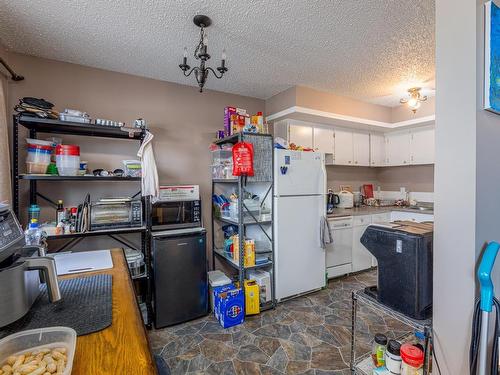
[179, 15, 228, 92]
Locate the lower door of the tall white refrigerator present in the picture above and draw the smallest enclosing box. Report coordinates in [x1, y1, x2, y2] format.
[274, 196, 325, 300]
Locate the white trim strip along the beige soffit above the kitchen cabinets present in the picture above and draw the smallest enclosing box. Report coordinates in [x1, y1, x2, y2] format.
[266, 106, 436, 129]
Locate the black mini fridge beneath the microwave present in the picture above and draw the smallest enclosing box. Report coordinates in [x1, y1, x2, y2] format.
[153, 228, 208, 328]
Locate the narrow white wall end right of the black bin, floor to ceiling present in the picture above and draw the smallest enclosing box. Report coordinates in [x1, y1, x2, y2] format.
[433, 0, 476, 375]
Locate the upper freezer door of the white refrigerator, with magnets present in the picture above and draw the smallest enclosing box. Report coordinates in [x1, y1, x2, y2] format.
[274, 149, 326, 196]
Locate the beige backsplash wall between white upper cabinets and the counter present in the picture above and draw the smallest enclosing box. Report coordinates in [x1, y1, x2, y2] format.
[326, 165, 434, 192]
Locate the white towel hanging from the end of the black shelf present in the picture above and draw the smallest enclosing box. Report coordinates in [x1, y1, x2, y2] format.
[137, 131, 160, 201]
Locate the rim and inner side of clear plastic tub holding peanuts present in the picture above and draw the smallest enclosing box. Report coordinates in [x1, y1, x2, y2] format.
[0, 327, 76, 375]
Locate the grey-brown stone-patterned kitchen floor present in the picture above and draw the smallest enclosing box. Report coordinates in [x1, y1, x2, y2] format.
[149, 271, 405, 375]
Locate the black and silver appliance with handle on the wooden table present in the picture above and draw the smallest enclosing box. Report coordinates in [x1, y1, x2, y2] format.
[0, 204, 61, 327]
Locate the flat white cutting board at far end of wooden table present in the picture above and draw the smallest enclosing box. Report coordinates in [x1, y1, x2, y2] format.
[54, 250, 113, 276]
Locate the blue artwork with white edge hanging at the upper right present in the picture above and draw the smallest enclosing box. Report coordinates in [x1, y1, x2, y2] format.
[484, 1, 500, 114]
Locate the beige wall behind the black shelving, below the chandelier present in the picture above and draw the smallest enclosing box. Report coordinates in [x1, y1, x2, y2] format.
[4, 54, 264, 256]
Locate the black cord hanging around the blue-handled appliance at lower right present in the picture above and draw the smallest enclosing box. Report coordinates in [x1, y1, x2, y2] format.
[469, 298, 500, 375]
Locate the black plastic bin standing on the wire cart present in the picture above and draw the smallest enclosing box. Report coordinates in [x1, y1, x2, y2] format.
[361, 222, 433, 320]
